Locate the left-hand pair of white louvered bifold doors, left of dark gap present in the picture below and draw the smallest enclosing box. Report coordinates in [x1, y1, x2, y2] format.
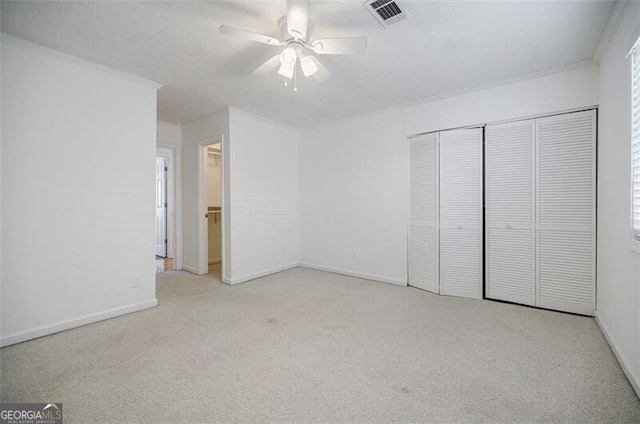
[409, 128, 482, 298]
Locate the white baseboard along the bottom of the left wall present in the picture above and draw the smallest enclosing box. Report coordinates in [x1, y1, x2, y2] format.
[0, 298, 158, 347]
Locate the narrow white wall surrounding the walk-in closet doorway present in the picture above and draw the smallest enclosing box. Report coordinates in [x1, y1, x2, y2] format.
[182, 109, 232, 276]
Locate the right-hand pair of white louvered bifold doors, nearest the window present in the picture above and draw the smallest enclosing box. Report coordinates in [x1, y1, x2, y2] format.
[485, 110, 596, 315]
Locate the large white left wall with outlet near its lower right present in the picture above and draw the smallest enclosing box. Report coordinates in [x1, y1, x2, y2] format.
[1, 36, 157, 345]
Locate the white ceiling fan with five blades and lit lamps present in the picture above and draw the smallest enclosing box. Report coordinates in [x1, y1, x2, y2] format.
[220, 0, 367, 91]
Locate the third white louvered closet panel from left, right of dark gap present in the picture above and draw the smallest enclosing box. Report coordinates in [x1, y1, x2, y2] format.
[484, 119, 536, 305]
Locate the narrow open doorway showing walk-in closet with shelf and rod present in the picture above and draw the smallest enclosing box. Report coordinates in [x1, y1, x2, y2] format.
[198, 138, 225, 281]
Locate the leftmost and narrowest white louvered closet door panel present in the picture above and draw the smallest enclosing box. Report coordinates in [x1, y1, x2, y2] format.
[409, 133, 440, 293]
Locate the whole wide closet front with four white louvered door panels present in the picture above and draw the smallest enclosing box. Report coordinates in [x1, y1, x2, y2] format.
[408, 110, 596, 315]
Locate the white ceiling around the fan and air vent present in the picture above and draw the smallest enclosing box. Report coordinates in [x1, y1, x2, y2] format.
[1, 0, 614, 128]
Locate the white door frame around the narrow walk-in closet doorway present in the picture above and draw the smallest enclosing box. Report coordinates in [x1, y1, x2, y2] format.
[196, 134, 227, 283]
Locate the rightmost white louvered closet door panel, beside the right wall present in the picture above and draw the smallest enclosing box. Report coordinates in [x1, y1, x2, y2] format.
[536, 110, 596, 315]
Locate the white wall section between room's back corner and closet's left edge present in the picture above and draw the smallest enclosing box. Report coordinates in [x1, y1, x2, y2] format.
[299, 111, 409, 284]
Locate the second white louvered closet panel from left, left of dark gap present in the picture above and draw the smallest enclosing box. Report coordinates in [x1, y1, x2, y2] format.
[440, 128, 482, 298]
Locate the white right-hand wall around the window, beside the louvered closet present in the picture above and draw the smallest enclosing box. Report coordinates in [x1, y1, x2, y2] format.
[596, 2, 640, 394]
